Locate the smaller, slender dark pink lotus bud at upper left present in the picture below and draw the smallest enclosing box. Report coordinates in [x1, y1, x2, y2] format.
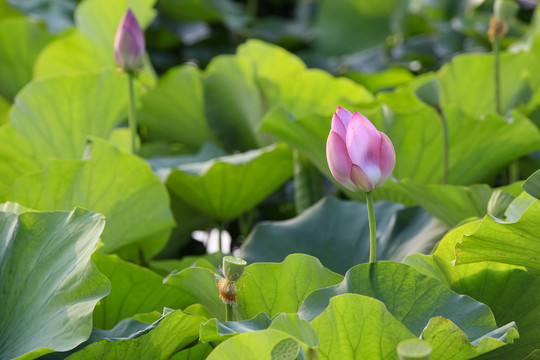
[114, 9, 145, 73]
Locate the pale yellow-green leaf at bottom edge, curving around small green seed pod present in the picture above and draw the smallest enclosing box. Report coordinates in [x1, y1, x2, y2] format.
[206, 329, 298, 360]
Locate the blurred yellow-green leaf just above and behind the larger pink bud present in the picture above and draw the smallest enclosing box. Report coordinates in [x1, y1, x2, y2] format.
[279, 69, 374, 117]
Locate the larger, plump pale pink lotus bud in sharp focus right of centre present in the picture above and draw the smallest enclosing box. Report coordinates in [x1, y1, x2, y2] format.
[326, 106, 396, 192]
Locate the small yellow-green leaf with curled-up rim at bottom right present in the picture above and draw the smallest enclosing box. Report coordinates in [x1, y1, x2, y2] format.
[422, 316, 519, 360]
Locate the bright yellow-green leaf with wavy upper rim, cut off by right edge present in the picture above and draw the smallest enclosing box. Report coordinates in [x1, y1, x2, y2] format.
[456, 200, 540, 270]
